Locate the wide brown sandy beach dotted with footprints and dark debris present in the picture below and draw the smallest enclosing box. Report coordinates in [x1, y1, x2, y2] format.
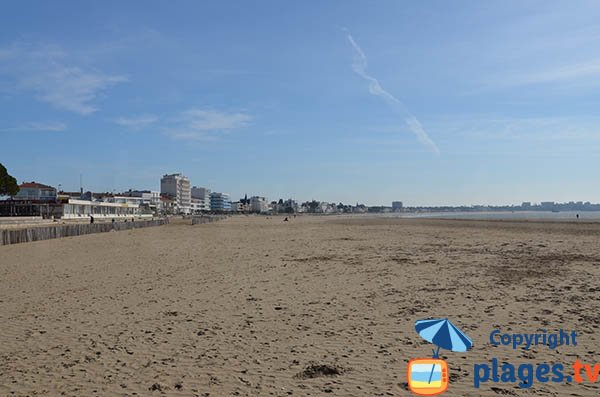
[0, 216, 600, 396]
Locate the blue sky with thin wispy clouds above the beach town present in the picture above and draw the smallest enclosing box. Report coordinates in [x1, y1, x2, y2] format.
[0, 1, 600, 205]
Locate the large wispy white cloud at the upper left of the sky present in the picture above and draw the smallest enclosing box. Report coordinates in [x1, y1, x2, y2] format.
[0, 43, 127, 115]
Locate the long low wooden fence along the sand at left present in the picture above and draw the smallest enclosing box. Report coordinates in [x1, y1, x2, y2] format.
[0, 219, 169, 245]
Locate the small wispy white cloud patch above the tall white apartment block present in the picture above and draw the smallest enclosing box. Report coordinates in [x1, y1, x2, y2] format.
[166, 109, 252, 140]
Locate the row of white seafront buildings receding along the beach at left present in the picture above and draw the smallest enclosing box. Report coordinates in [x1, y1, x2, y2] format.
[0, 173, 402, 219]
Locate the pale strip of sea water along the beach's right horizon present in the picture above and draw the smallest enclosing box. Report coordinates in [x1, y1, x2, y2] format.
[389, 211, 600, 222]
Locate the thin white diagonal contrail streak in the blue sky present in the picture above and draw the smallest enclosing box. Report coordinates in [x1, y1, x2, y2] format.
[348, 33, 440, 153]
